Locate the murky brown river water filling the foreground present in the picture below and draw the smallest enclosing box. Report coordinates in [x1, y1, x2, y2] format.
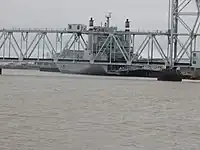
[0, 70, 200, 150]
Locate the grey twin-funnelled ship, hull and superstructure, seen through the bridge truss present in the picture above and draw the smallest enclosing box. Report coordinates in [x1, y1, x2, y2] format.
[57, 14, 145, 75]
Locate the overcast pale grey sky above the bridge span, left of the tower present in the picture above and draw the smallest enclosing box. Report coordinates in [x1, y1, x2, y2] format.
[0, 0, 168, 29]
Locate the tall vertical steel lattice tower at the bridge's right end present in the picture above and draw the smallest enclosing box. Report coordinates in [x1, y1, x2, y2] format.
[169, 0, 200, 66]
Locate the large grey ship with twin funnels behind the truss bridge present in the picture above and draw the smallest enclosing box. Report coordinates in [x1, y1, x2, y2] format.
[57, 14, 141, 75]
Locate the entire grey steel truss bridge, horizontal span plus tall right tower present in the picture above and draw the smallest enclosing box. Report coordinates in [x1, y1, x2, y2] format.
[0, 0, 200, 66]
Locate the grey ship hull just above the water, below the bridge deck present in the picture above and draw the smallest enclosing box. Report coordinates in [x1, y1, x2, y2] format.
[57, 63, 107, 75]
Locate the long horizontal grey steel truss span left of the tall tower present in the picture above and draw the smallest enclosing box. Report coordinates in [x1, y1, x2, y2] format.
[0, 29, 199, 65]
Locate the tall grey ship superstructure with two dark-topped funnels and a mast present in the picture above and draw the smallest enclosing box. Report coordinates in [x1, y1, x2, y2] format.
[88, 14, 131, 62]
